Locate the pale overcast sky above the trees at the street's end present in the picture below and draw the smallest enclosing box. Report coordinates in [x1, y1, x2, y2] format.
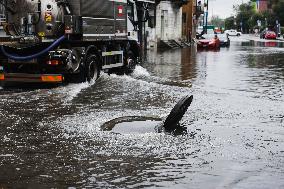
[208, 0, 249, 18]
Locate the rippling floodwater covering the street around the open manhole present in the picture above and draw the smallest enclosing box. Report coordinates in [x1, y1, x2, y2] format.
[0, 36, 284, 189]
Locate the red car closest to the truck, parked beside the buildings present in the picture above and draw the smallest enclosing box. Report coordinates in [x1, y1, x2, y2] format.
[197, 34, 220, 50]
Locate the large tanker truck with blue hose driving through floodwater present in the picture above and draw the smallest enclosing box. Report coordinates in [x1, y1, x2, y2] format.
[0, 0, 154, 85]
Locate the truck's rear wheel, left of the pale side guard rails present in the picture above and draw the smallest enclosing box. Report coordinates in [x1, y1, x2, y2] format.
[86, 55, 100, 82]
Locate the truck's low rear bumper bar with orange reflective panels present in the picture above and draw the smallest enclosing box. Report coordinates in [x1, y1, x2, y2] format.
[0, 73, 64, 83]
